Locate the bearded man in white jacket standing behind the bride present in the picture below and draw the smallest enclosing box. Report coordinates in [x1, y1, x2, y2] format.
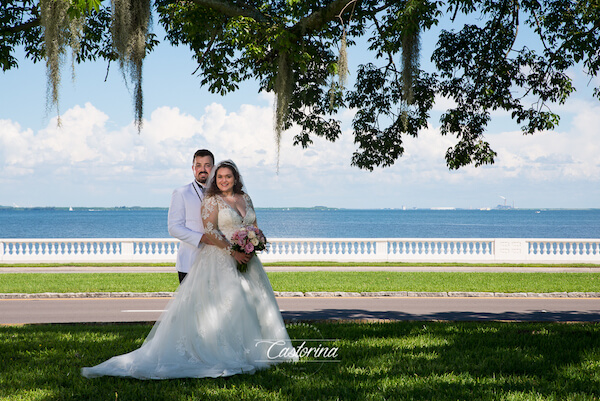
[168, 149, 215, 283]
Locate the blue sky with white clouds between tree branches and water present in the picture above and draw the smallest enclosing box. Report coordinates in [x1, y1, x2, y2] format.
[0, 16, 600, 209]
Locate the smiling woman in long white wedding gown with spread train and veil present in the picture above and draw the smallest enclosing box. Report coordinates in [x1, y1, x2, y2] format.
[81, 160, 298, 379]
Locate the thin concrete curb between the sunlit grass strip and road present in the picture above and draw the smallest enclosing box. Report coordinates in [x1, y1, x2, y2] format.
[0, 291, 600, 299]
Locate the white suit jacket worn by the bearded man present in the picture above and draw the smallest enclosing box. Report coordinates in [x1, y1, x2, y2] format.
[168, 181, 204, 273]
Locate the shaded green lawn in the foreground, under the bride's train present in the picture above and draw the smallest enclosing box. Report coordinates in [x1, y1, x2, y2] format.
[0, 322, 600, 401]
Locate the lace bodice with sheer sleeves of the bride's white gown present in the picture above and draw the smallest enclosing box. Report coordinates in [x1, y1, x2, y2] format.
[202, 194, 256, 242]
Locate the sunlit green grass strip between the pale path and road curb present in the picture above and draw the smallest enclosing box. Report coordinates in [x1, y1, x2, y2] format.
[0, 272, 600, 293]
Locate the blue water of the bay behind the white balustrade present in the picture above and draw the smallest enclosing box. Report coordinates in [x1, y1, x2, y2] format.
[0, 208, 600, 238]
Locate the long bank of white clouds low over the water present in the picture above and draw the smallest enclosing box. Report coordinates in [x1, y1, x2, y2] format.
[0, 98, 600, 208]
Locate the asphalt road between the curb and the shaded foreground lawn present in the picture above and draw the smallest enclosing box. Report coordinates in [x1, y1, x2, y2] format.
[0, 297, 600, 325]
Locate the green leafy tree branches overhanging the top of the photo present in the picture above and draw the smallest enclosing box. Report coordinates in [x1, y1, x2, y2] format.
[0, 0, 600, 170]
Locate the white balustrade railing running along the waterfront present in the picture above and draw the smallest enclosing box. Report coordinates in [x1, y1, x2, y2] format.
[0, 238, 600, 263]
